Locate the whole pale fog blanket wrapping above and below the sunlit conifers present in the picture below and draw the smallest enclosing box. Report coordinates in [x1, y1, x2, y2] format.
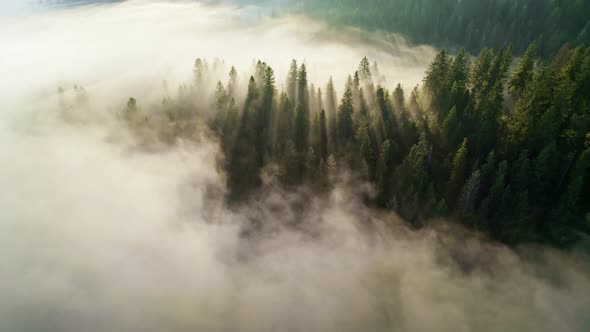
[0, 2, 590, 332]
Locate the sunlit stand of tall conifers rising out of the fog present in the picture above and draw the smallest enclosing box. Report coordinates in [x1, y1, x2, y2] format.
[115, 44, 590, 243]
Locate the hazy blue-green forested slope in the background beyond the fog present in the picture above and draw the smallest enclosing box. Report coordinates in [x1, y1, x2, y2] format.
[294, 0, 590, 56]
